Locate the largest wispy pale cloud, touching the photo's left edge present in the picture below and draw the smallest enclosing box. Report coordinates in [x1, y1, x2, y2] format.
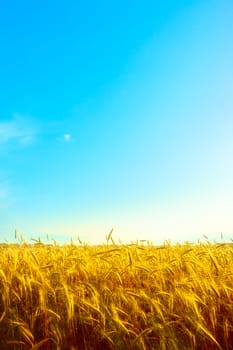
[0, 113, 37, 146]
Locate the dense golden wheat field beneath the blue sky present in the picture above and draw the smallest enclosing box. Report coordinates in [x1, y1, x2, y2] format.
[0, 237, 233, 350]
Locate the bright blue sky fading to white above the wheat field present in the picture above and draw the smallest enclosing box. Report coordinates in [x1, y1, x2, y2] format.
[0, 0, 233, 243]
